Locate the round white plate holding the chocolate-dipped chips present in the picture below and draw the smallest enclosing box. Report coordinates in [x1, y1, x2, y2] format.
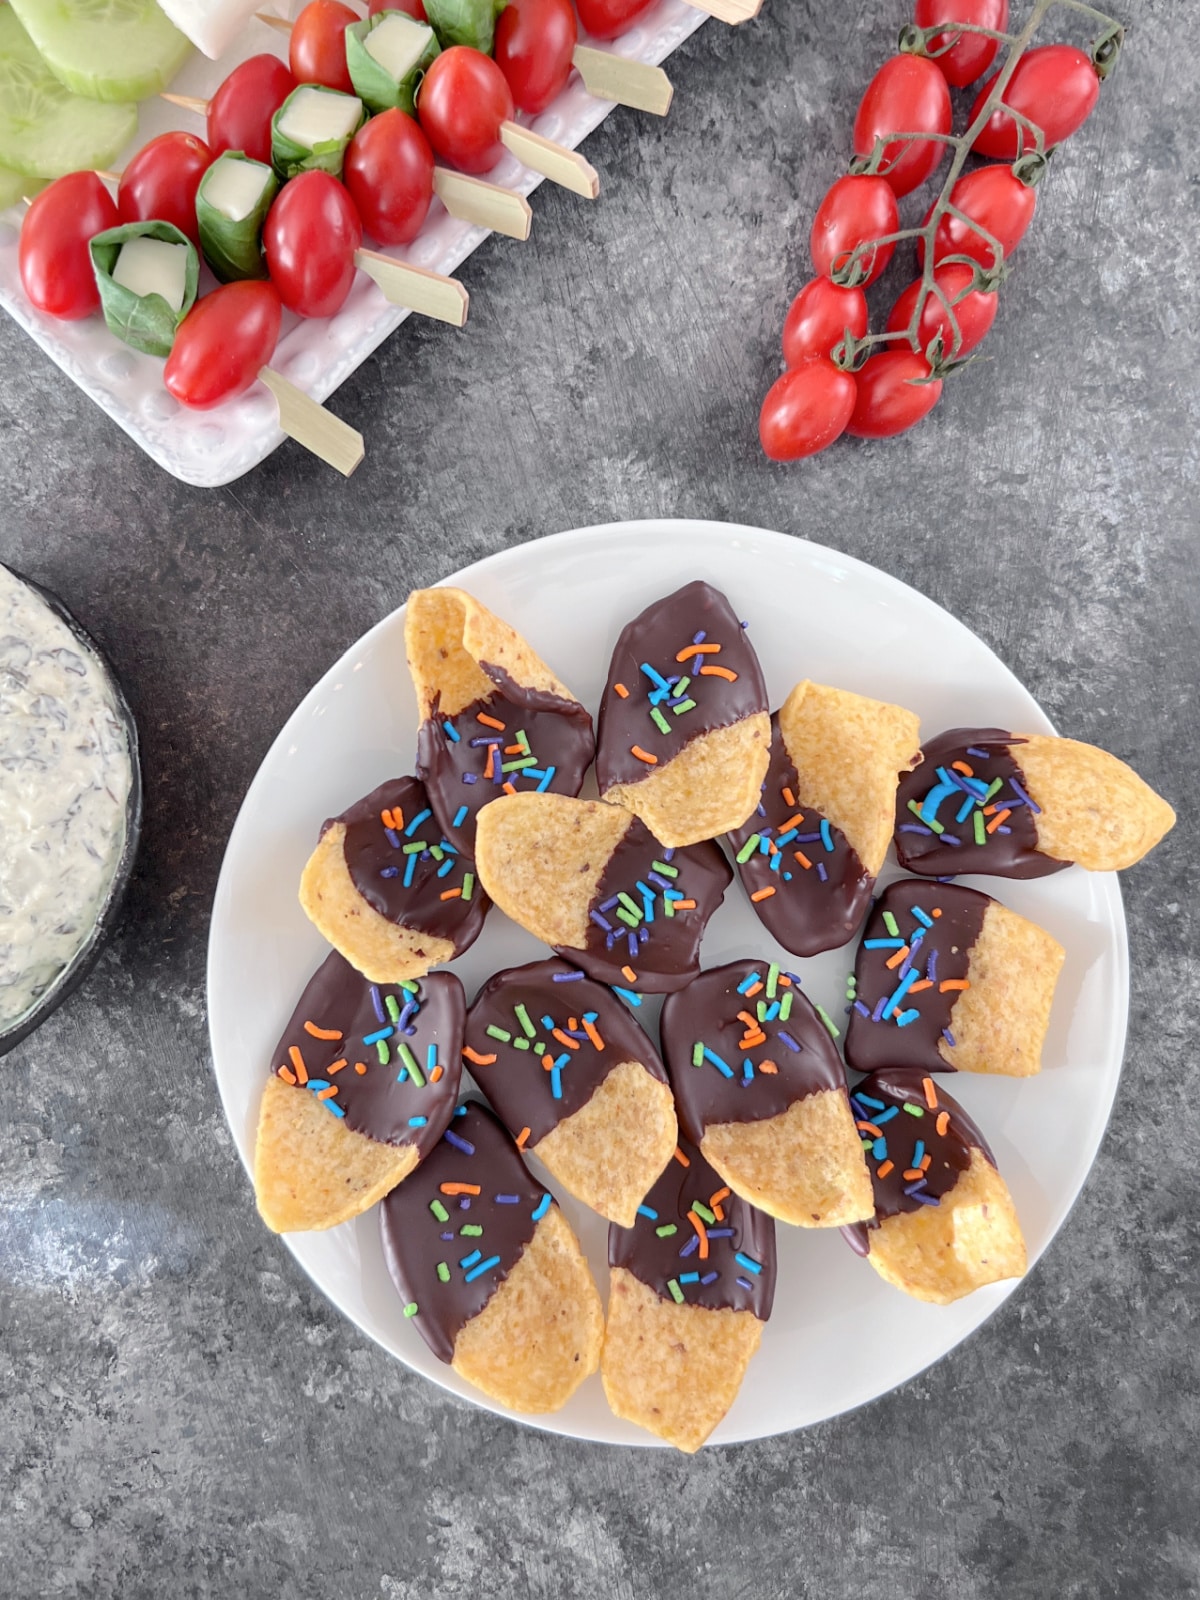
[208, 522, 1128, 1445]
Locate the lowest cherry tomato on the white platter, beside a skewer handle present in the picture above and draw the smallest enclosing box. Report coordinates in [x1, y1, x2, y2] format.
[163, 278, 282, 411]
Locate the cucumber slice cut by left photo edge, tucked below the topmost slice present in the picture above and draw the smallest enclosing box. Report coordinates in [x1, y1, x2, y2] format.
[0, 5, 138, 178]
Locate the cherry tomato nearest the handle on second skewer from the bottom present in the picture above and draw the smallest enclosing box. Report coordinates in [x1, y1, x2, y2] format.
[262, 171, 363, 317]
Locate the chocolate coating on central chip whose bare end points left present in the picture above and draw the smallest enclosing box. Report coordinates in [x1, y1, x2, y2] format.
[569, 818, 733, 994]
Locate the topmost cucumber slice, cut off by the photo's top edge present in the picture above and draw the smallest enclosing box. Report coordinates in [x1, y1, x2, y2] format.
[10, 0, 192, 101]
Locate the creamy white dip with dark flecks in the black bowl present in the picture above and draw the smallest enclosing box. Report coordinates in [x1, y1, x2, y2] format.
[0, 566, 133, 1030]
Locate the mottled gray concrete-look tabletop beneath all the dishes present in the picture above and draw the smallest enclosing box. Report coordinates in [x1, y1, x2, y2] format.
[0, 0, 1200, 1600]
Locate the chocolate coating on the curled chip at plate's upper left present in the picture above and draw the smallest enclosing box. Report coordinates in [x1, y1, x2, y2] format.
[416, 661, 595, 856]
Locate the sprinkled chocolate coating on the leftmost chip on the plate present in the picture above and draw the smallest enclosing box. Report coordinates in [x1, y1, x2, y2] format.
[272, 950, 467, 1160]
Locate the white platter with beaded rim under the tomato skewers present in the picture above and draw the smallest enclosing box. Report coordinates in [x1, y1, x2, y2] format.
[0, 0, 707, 488]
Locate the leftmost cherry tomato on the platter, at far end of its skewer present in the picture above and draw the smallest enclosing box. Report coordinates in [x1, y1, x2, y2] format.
[19, 173, 120, 322]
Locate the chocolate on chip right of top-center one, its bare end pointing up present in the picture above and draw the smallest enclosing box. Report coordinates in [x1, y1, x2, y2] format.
[726, 712, 875, 955]
